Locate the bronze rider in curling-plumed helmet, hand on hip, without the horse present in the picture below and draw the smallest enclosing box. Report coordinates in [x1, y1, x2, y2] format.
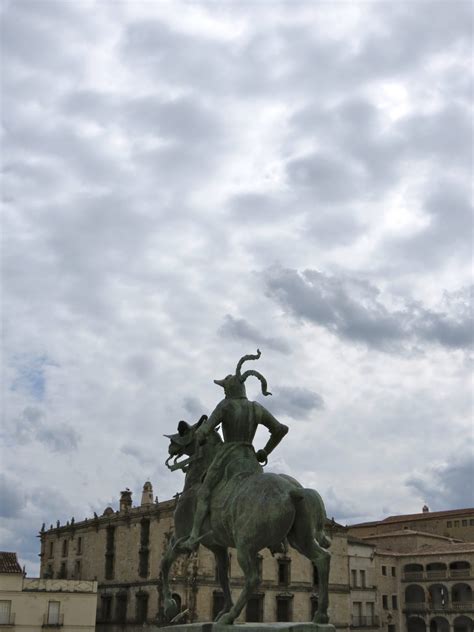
[181, 349, 288, 550]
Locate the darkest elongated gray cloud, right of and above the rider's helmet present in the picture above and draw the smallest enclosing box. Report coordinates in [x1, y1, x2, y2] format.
[265, 268, 472, 351]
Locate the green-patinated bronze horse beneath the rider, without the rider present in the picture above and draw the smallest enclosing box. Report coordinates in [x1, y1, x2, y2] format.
[161, 414, 330, 627]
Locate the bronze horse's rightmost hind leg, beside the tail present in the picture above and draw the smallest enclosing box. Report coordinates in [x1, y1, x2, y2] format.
[288, 498, 331, 623]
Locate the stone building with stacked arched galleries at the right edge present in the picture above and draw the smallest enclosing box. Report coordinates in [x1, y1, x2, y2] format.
[349, 508, 474, 632]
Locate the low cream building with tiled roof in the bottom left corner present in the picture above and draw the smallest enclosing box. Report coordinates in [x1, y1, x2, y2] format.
[0, 552, 97, 632]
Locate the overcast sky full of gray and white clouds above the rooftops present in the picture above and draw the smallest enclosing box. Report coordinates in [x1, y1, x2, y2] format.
[0, 0, 474, 575]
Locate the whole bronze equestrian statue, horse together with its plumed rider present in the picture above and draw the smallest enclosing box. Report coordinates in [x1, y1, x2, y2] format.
[161, 350, 330, 624]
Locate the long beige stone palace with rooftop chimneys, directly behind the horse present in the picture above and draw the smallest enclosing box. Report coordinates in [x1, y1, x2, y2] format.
[37, 483, 378, 630]
